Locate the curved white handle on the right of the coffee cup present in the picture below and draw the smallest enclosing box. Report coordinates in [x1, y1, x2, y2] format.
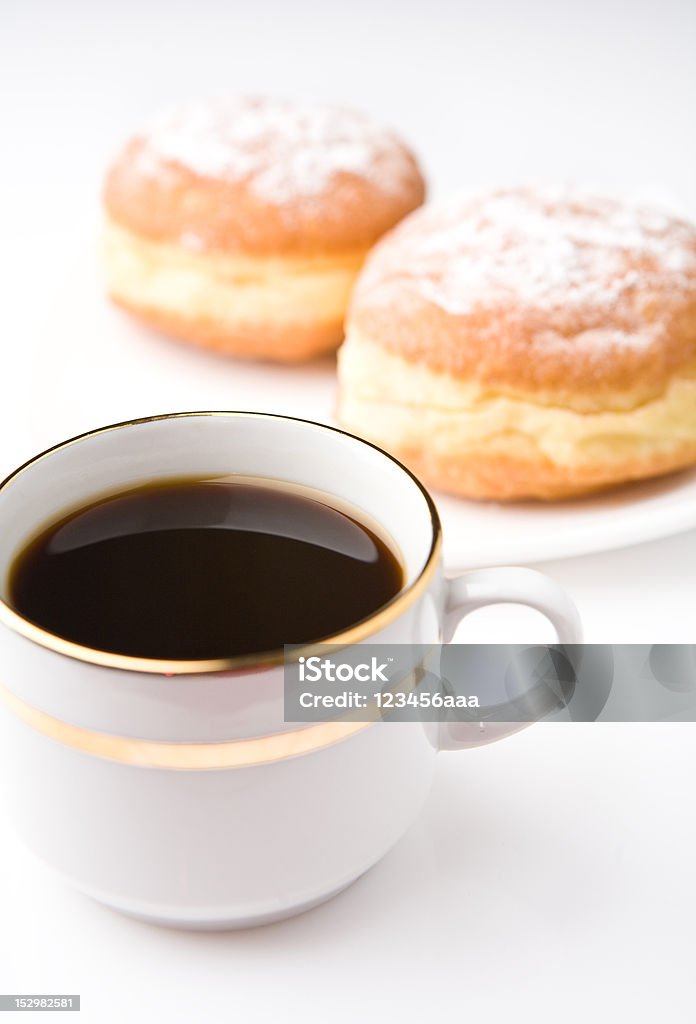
[438, 566, 582, 751]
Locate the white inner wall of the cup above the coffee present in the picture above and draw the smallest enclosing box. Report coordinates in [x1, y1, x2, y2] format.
[0, 413, 439, 603]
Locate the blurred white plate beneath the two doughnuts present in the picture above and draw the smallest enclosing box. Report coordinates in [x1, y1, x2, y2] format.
[30, 246, 696, 569]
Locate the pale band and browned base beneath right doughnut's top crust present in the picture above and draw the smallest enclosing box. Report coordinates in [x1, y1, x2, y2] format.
[337, 333, 696, 501]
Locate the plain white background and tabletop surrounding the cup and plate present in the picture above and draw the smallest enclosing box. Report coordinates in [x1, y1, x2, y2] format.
[0, 0, 696, 1024]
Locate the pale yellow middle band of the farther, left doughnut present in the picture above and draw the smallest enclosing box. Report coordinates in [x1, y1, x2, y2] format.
[103, 220, 364, 333]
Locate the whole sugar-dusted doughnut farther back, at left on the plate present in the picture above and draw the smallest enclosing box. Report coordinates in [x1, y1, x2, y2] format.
[104, 98, 425, 360]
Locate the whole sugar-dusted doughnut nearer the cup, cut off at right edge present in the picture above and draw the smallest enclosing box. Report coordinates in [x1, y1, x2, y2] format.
[339, 188, 696, 500]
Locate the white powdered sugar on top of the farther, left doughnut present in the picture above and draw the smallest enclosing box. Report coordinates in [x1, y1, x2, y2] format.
[140, 98, 414, 204]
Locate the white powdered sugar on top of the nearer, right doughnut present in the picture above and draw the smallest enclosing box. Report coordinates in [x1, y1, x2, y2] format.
[359, 187, 696, 348]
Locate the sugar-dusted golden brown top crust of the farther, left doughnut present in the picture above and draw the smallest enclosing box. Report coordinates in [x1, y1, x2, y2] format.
[103, 97, 425, 256]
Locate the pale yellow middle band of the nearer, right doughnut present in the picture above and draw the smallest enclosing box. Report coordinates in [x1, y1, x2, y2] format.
[339, 331, 696, 467]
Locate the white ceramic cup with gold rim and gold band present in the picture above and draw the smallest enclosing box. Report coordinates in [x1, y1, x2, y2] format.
[0, 413, 580, 928]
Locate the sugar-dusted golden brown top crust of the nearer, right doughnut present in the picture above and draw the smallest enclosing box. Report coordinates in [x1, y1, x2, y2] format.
[347, 188, 696, 409]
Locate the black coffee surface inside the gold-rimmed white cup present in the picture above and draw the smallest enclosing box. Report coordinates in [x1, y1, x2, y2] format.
[10, 480, 403, 659]
